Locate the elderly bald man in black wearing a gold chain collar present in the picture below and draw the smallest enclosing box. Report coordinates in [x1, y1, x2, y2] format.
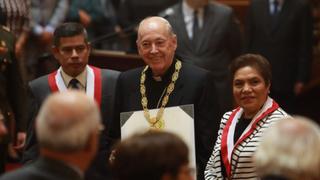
[110, 17, 220, 177]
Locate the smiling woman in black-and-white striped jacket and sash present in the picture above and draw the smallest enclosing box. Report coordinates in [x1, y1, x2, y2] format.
[205, 54, 288, 180]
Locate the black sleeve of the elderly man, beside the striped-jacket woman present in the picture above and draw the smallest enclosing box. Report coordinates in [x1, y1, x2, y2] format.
[195, 72, 222, 179]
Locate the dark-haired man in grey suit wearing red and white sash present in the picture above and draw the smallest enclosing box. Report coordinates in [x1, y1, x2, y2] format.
[24, 23, 119, 180]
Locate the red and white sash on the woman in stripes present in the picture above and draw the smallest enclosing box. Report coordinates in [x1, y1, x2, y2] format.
[221, 97, 279, 178]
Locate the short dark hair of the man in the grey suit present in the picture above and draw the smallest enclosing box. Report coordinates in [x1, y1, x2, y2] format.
[53, 22, 88, 47]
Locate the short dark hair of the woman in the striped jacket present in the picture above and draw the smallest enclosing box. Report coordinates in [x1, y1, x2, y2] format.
[229, 54, 272, 85]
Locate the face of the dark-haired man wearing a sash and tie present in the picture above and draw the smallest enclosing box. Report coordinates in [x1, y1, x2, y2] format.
[52, 34, 91, 77]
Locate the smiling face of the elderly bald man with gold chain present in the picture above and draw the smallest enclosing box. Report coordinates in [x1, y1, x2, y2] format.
[137, 19, 177, 76]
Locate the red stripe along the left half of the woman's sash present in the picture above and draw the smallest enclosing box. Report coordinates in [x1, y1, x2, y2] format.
[221, 107, 240, 177]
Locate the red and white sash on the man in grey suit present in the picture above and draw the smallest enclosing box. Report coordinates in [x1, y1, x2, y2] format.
[48, 66, 102, 107]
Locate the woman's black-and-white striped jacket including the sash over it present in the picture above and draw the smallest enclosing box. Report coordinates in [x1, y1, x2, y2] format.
[205, 98, 288, 180]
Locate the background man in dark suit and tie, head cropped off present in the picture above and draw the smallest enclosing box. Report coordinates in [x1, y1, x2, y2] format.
[162, 0, 242, 112]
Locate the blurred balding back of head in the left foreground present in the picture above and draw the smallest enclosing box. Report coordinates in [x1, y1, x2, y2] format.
[36, 91, 101, 152]
